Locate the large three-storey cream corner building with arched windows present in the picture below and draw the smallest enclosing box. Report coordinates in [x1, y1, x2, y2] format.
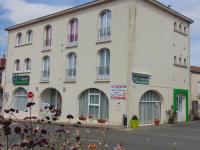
[5, 0, 193, 125]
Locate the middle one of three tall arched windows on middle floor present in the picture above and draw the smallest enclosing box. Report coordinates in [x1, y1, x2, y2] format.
[66, 53, 76, 80]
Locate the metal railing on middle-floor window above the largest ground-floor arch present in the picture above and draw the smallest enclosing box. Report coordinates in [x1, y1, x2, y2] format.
[97, 66, 110, 80]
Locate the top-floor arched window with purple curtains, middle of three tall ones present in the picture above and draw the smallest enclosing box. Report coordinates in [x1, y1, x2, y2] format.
[68, 18, 78, 43]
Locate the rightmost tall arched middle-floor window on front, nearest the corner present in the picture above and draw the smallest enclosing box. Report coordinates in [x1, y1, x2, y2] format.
[97, 49, 110, 80]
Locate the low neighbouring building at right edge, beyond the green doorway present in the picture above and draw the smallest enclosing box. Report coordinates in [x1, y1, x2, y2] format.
[190, 66, 200, 119]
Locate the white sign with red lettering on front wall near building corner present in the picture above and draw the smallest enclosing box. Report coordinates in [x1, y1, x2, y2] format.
[111, 84, 127, 100]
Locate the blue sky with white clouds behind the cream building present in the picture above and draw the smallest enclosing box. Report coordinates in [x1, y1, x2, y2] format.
[0, 0, 200, 66]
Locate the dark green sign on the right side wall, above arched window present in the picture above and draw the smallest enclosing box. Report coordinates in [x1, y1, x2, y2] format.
[132, 73, 151, 85]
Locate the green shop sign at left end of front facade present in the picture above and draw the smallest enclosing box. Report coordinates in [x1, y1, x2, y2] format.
[13, 74, 29, 85]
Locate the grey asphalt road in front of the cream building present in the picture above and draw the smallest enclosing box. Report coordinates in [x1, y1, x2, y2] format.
[1, 121, 200, 150]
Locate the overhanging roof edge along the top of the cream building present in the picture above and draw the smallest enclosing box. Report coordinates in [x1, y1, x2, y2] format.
[5, 0, 194, 31]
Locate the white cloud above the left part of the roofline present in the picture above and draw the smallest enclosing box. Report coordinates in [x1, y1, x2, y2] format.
[0, 0, 70, 23]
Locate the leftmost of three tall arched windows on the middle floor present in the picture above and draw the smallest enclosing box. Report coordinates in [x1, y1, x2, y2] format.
[42, 56, 50, 81]
